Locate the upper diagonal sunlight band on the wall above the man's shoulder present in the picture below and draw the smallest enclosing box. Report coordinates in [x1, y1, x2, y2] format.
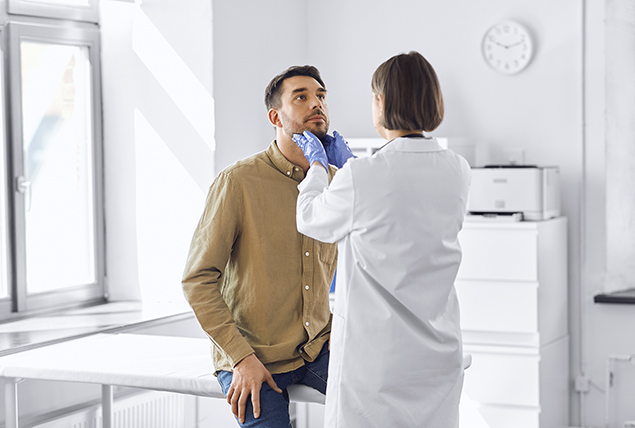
[132, 6, 215, 150]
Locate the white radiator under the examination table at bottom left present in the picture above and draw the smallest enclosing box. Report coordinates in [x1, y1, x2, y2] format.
[34, 391, 185, 428]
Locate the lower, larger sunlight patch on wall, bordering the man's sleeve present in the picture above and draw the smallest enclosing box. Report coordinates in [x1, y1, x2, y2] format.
[134, 109, 205, 305]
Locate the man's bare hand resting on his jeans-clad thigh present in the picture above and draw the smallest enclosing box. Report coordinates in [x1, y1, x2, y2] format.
[227, 354, 282, 424]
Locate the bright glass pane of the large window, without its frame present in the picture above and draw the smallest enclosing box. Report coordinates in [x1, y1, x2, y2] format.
[20, 41, 96, 294]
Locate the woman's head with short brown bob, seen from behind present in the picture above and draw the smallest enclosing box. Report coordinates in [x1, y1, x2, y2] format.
[371, 51, 444, 132]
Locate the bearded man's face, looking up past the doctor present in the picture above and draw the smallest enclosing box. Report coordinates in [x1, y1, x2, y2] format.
[278, 76, 329, 139]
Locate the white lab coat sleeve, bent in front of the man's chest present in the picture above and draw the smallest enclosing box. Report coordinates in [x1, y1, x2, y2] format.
[296, 163, 355, 243]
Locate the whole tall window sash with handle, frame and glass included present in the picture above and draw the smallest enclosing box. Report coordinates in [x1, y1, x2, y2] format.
[0, 23, 104, 316]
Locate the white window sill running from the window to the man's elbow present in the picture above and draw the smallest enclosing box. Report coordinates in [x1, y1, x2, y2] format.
[0, 302, 193, 356]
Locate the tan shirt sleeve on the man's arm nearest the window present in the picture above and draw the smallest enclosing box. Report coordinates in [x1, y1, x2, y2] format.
[182, 173, 254, 366]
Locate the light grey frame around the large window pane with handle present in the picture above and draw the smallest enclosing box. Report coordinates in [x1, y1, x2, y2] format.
[5, 22, 106, 318]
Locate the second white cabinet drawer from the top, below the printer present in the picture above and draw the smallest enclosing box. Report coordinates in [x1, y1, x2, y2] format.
[455, 281, 538, 333]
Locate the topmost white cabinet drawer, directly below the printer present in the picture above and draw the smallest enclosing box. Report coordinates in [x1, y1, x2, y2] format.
[457, 229, 538, 281]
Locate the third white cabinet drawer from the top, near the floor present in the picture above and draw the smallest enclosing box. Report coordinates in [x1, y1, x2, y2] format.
[463, 345, 540, 406]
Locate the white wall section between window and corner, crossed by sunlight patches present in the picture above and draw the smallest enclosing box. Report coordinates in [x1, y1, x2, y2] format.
[100, 0, 215, 303]
